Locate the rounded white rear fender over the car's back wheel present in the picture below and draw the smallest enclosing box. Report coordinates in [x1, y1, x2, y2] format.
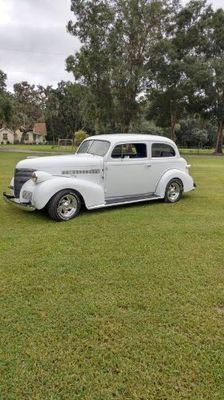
[155, 169, 194, 197]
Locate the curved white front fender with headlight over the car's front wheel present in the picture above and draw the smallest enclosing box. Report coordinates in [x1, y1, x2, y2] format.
[22, 176, 104, 210]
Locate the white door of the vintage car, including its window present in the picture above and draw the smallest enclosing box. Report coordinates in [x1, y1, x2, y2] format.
[105, 143, 151, 201]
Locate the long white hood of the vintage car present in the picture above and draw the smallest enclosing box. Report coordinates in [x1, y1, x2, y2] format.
[16, 154, 103, 174]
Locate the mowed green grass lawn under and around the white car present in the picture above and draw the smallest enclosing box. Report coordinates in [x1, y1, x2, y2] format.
[0, 153, 224, 400]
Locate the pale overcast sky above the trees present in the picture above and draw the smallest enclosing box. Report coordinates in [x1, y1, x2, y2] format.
[0, 0, 224, 90]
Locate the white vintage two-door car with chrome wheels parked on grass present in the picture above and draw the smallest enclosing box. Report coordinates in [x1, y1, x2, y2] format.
[3, 134, 195, 221]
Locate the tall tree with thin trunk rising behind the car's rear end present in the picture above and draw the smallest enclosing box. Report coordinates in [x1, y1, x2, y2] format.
[147, 0, 207, 140]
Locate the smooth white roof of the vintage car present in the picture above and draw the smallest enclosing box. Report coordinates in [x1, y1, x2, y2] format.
[86, 133, 175, 145]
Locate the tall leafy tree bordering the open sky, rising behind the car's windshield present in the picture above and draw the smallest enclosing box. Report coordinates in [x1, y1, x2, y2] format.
[67, 0, 113, 133]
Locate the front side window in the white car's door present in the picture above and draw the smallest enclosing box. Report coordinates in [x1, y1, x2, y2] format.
[111, 143, 147, 158]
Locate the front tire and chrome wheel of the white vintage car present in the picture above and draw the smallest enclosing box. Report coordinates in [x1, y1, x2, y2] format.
[47, 189, 81, 222]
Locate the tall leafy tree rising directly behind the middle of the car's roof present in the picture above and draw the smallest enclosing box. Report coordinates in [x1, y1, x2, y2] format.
[110, 0, 168, 132]
